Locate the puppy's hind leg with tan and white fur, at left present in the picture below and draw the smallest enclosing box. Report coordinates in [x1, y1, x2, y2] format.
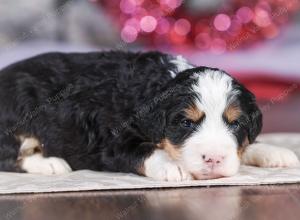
[19, 137, 72, 175]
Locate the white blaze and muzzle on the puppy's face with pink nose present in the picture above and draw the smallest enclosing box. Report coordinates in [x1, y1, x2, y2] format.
[182, 70, 240, 179]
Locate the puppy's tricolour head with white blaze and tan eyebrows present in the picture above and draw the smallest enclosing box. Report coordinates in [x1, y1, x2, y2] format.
[152, 67, 262, 179]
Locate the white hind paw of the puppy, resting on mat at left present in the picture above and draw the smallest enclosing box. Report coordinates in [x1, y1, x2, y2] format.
[21, 154, 72, 175]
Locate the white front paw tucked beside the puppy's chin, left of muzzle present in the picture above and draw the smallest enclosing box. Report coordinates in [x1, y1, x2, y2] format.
[144, 150, 193, 182]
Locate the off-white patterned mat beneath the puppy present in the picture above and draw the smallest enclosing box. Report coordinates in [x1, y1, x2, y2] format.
[0, 133, 300, 194]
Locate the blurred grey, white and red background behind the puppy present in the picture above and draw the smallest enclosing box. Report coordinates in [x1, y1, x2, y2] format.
[0, 0, 300, 132]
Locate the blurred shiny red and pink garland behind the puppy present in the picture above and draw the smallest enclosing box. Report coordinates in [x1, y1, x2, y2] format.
[100, 0, 299, 53]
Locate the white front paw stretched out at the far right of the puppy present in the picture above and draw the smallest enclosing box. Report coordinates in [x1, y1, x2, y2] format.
[242, 143, 300, 167]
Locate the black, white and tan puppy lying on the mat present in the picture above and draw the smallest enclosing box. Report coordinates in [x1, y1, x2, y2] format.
[0, 51, 299, 181]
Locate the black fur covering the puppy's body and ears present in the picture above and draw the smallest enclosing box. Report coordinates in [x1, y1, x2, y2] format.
[0, 51, 261, 173]
